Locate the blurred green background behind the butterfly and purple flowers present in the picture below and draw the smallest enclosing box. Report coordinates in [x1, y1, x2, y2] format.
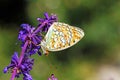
[0, 0, 120, 80]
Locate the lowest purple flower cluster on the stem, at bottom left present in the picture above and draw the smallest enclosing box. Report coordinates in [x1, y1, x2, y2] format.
[3, 52, 34, 80]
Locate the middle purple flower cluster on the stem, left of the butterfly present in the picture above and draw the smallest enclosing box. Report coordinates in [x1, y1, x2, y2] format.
[18, 24, 42, 55]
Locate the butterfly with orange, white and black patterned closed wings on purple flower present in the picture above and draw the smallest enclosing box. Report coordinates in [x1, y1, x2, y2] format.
[40, 22, 84, 55]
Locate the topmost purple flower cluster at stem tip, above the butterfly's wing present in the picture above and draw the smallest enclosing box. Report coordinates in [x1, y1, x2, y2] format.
[37, 13, 57, 32]
